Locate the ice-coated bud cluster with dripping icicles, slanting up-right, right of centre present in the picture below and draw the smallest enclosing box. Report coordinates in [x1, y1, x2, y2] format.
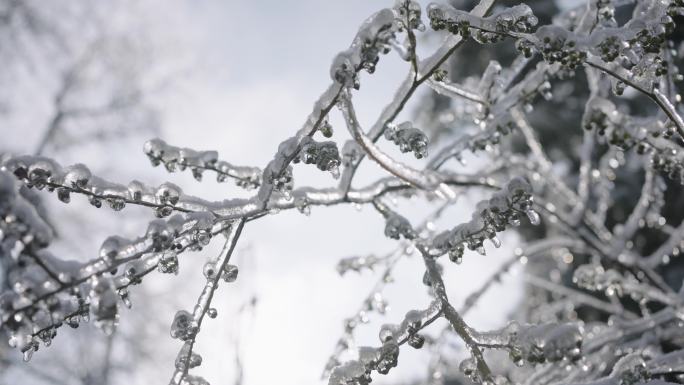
[432, 177, 540, 263]
